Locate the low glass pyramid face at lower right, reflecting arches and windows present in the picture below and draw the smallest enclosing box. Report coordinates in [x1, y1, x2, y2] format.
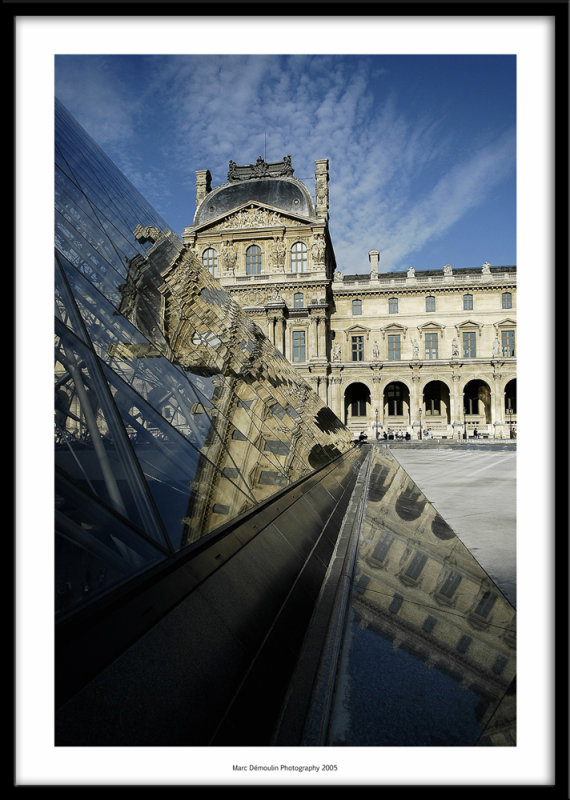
[327, 449, 516, 747]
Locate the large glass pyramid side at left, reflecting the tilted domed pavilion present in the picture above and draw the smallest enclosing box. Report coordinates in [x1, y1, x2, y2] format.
[54, 102, 352, 615]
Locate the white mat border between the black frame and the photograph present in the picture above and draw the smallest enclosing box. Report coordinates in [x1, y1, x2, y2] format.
[16, 14, 552, 786]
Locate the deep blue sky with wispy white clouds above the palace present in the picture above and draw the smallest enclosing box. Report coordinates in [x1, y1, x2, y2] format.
[55, 54, 516, 273]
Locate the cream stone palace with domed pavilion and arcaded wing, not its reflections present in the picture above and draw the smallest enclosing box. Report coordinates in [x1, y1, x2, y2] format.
[182, 156, 516, 439]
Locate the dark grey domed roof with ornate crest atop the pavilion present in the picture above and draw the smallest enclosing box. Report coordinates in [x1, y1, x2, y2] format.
[194, 159, 315, 225]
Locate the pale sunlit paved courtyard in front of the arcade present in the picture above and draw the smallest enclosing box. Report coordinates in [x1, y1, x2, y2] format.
[384, 444, 516, 607]
